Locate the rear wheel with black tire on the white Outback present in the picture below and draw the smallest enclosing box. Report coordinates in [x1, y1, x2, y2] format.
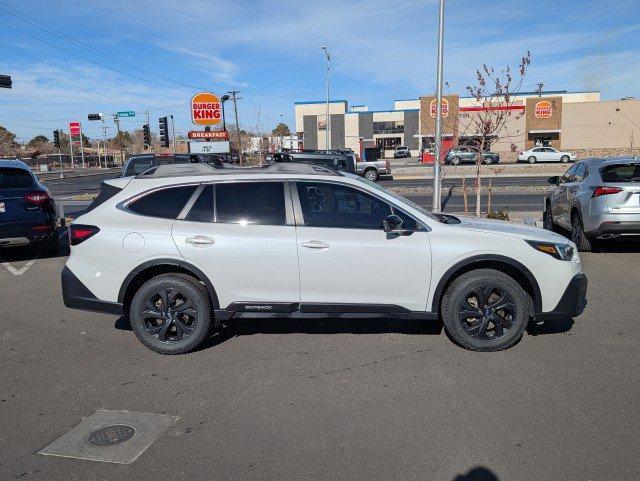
[129, 274, 211, 354]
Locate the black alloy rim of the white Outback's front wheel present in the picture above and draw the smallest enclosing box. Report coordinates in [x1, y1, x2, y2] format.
[458, 284, 517, 341]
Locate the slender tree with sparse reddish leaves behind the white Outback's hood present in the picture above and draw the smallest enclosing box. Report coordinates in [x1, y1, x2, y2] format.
[459, 51, 531, 217]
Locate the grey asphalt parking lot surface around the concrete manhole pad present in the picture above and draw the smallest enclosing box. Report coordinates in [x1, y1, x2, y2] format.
[0, 238, 640, 481]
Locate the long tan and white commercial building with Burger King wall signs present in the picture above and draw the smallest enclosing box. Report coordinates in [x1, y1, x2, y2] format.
[294, 90, 640, 156]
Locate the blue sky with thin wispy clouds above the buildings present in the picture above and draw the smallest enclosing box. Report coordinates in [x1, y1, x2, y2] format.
[0, 0, 640, 140]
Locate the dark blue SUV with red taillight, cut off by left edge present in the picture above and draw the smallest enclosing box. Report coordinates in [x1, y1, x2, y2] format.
[0, 160, 60, 255]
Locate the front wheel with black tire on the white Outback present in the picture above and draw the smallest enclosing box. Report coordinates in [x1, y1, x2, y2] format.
[441, 269, 531, 351]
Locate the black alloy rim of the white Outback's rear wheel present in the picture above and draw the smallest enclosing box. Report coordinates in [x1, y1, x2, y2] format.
[142, 288, 198, 342]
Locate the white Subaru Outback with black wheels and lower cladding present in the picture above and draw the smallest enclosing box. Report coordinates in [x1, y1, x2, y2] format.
[62, 164, 587, 354]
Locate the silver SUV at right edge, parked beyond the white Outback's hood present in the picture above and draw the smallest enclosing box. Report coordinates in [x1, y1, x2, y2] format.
[544, 157, 640, 251]
